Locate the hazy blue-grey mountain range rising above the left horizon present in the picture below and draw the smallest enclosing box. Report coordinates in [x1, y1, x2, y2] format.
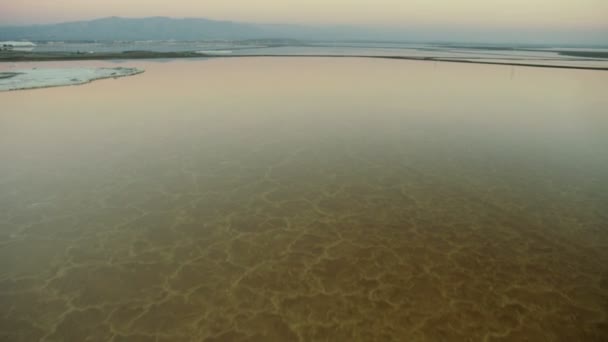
[0, 17, 390, 41]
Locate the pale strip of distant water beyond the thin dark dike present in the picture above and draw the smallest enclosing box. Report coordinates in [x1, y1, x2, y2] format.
[19, 40, 608, 69]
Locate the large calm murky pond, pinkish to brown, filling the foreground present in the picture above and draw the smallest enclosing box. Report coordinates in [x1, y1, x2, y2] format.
[0, 58, 608, 341]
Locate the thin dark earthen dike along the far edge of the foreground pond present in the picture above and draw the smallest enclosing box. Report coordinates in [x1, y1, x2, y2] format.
[0, 51, 608, 71]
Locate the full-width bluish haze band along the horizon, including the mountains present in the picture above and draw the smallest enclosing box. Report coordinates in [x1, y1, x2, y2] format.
[0, 17, 608, 45]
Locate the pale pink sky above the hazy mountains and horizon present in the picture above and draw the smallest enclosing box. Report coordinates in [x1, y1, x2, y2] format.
[0, 0, 608, 30]
